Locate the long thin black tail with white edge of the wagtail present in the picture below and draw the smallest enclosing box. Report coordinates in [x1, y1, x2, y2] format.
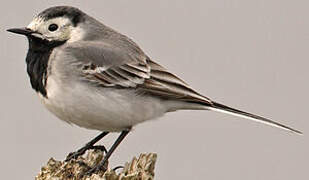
[207, 101, 303, 135]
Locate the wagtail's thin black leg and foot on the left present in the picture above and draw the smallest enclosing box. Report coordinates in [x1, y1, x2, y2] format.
[65, 132, 109, 161]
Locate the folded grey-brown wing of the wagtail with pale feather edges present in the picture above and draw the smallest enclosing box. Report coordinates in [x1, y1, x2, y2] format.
[69, 42, 211, 104]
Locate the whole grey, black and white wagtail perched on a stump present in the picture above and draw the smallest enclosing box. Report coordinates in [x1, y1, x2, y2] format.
[8, 6, 301, 174]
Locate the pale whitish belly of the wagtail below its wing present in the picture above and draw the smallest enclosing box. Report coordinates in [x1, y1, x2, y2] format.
[40, 76, 167, 131]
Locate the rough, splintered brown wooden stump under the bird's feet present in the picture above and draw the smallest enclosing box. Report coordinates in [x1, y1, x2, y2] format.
[35, 150, 157, 180]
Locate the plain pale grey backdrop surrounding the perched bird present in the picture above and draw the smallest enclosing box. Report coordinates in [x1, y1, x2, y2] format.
[0, 0, 309, 180]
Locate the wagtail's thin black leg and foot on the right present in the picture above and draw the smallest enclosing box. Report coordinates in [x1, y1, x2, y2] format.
[86, 130, 130, 175]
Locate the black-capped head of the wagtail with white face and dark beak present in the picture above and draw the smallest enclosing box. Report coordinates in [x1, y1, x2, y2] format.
[8, 6, 87, 46]
